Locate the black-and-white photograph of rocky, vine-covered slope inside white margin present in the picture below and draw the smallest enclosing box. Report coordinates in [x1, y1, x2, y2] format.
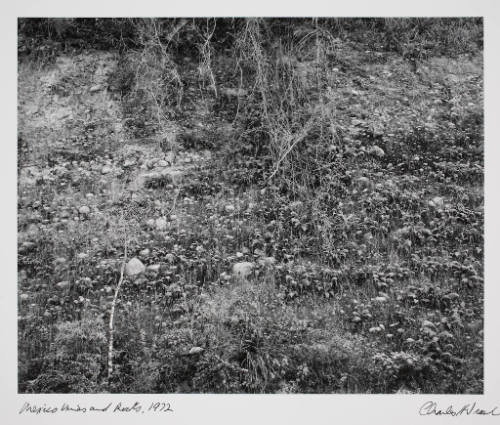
[17, 17, 484, 396]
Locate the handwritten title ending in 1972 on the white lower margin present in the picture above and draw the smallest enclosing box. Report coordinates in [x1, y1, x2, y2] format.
[19, 401, 173, 415]
